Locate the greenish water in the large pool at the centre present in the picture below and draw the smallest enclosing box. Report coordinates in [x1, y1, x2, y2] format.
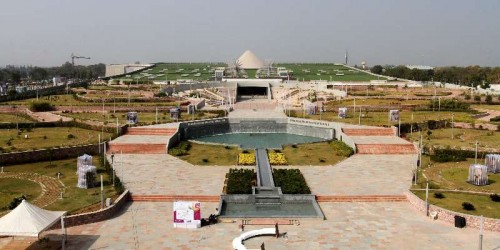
[191, 133, 324, 149]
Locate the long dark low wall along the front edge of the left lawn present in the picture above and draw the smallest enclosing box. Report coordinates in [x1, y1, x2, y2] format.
[0, 144, 99, 165]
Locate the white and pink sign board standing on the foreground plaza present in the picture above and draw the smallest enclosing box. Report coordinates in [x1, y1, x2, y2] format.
[173, 201, 201, 228]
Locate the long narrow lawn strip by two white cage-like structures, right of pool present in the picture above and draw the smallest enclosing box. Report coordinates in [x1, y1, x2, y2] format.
[291, 108, 474, 126]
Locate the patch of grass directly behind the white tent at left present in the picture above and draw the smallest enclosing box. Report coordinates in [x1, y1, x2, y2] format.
[0, 178, 42, 211]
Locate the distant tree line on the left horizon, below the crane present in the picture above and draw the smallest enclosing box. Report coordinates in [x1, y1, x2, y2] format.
[0, 62, 106, 84]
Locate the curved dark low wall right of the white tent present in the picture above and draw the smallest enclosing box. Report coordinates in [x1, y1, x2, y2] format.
[51, 190, 130, 229]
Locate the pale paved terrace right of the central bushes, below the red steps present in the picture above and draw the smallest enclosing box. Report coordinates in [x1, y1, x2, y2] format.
[282, 154, 415, 195]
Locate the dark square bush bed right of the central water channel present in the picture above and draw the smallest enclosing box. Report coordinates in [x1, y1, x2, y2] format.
[273, 169, 311, 194]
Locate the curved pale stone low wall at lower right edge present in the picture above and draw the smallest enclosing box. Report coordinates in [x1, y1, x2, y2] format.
[405, 191, 500, 232]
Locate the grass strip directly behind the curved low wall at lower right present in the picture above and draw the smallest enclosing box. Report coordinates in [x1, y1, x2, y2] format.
[414, 191, 500, 218]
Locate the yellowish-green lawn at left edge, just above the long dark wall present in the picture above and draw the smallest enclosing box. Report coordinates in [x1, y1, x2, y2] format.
[0, 127, 111, 152]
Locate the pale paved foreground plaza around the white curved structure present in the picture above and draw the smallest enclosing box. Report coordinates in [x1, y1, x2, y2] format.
[46, 202, 500, 250]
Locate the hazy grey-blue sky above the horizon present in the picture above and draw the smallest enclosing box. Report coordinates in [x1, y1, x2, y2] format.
[0, 0, 500, 67]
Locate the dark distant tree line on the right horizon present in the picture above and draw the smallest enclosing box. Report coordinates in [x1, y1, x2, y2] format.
[370, 65, 500, 88]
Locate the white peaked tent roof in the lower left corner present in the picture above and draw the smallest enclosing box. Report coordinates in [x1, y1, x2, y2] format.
[0, 200, 66, 237]
